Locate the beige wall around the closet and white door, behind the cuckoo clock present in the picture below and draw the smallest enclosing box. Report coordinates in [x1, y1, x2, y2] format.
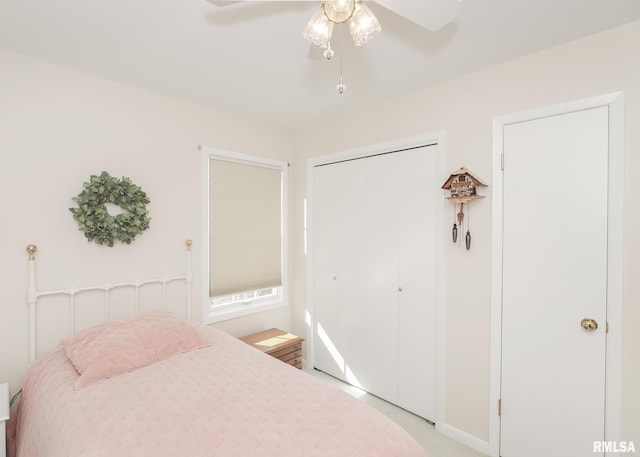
[293, 23, 640, 443]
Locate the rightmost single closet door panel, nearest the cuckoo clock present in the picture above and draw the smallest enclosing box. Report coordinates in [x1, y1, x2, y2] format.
[397, 145, 443, 420]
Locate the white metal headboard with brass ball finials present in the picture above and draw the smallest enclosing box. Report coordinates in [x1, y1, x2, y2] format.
[27, 240, 192, 364]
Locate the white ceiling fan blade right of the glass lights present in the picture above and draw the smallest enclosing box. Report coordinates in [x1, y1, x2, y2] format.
[373, 0, 462, 32]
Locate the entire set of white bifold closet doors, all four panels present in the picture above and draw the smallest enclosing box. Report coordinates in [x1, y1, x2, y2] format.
[313, 145, 443, 420]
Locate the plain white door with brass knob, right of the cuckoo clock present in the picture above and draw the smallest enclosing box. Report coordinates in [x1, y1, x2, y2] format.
[500, 107, 609, 457]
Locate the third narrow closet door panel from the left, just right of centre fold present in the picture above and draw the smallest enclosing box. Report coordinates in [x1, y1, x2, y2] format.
[366, 154, 399, 403]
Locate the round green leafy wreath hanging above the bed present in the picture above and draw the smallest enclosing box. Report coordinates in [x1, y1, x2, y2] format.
[69, 171, 150, 246]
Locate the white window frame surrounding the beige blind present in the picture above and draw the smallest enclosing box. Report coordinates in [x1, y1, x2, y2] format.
[198, 146, 289, 324]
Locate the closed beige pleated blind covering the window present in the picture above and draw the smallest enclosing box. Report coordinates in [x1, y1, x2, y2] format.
[209, 158, 282, 297]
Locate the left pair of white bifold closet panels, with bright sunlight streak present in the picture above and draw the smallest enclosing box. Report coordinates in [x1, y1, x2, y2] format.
[314, 160, 367, 386]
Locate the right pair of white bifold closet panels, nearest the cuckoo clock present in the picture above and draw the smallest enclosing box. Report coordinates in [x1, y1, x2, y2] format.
[363, 145, 442, 419]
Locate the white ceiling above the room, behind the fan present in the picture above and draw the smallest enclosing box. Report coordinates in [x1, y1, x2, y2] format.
[0, 0, 640, 126]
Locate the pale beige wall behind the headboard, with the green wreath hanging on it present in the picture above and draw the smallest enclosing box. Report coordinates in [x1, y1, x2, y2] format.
[0, 51, 292, 392]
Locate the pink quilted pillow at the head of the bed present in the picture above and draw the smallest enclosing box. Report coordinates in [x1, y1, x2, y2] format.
[60, 312, 209, 389]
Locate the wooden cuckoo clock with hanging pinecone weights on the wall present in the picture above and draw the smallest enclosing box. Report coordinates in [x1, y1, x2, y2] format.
[442, 167, 487, 250]
